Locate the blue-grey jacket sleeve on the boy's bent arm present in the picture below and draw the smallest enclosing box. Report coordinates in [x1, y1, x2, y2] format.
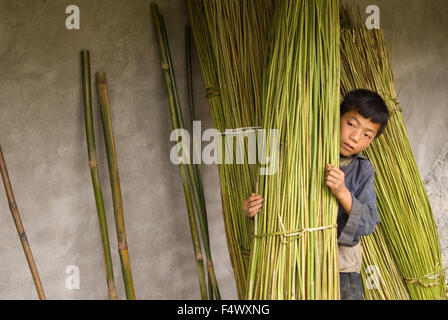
[338, 161, 380, 247]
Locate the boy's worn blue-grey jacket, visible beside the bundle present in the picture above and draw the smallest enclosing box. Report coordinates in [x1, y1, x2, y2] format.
[337, 154, 380, 247]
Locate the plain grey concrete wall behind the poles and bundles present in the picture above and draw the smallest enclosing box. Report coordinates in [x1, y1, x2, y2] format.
[0, 0, 448, 299]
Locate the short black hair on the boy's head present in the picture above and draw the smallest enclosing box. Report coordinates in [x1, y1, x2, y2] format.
[341, 89, 389, 138]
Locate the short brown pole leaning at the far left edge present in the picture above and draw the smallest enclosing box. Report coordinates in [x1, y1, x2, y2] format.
[0, 146, 46, 300]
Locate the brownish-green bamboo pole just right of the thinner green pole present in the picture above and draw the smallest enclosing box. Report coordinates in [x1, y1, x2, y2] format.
[95, 72, 135, 300]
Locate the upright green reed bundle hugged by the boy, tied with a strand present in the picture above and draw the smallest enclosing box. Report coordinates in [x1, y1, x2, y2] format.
[247, 0, 340, 299]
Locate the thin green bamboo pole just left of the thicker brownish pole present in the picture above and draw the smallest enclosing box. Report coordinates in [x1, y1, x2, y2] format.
[81, 50, 117, 300]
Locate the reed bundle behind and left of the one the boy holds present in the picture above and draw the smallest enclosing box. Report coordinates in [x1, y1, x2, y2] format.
[188, 0, 273, 298]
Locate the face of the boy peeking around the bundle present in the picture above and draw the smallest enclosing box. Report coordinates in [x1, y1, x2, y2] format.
[340, 111, 381, 157]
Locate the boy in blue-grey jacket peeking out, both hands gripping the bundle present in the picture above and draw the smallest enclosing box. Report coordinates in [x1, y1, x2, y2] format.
[243, 89, 389, 300]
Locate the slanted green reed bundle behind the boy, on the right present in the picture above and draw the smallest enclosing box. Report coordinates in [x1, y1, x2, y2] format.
[341, 9, 447, 300]
